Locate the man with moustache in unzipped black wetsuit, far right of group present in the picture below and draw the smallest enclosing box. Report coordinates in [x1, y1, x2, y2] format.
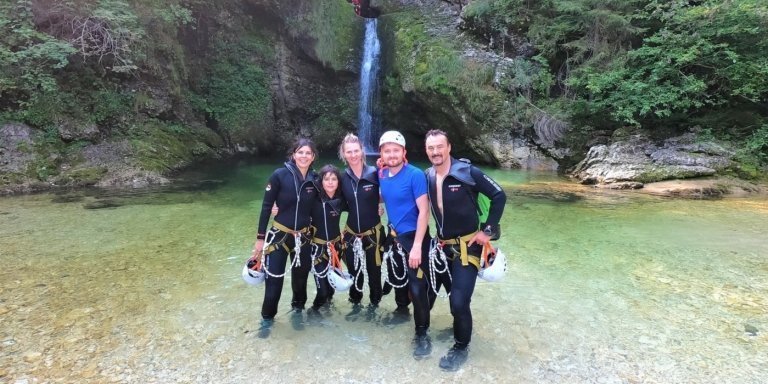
[425, 129, 507, 371]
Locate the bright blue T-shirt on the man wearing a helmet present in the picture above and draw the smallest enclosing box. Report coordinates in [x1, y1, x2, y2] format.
[379, 164, 427, 235]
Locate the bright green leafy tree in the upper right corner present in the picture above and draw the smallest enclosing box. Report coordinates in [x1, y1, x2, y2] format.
[585, 0, 768, 124]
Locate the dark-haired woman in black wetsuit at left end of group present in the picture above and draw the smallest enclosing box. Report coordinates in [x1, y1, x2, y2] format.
[251, 138, 318, 334]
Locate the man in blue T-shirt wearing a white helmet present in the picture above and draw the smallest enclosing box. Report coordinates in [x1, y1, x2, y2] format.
[379, 131, 432, 359]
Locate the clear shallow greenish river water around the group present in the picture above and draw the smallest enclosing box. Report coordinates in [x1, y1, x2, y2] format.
[0, 162, 768, 383]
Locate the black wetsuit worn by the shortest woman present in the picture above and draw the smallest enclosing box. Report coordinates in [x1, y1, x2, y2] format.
[312, 190, 347, 309]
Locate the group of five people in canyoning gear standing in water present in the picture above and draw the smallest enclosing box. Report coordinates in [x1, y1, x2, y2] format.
[248, 130, 506, 371]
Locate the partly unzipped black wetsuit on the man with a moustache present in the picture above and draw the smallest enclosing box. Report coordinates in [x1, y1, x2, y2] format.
[426, 157, 507, 349]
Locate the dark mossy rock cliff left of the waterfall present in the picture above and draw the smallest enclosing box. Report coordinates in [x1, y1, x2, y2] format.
[0, 0, 362, 193]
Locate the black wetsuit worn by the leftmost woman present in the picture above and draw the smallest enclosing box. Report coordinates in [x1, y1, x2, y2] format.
[257, 162, 317, 319]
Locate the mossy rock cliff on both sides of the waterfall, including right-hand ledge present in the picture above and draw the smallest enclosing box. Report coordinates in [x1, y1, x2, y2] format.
[0, 0, 764, 193]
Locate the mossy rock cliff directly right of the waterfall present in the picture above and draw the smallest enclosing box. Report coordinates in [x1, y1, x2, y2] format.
[378, 0, 564, 170]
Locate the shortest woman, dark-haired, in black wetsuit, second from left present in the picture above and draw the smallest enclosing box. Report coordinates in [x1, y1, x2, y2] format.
[312, 164, 347, 311]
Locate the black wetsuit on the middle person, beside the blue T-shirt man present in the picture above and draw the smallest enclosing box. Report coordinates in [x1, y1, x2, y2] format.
[340, 166, 384, 305]
